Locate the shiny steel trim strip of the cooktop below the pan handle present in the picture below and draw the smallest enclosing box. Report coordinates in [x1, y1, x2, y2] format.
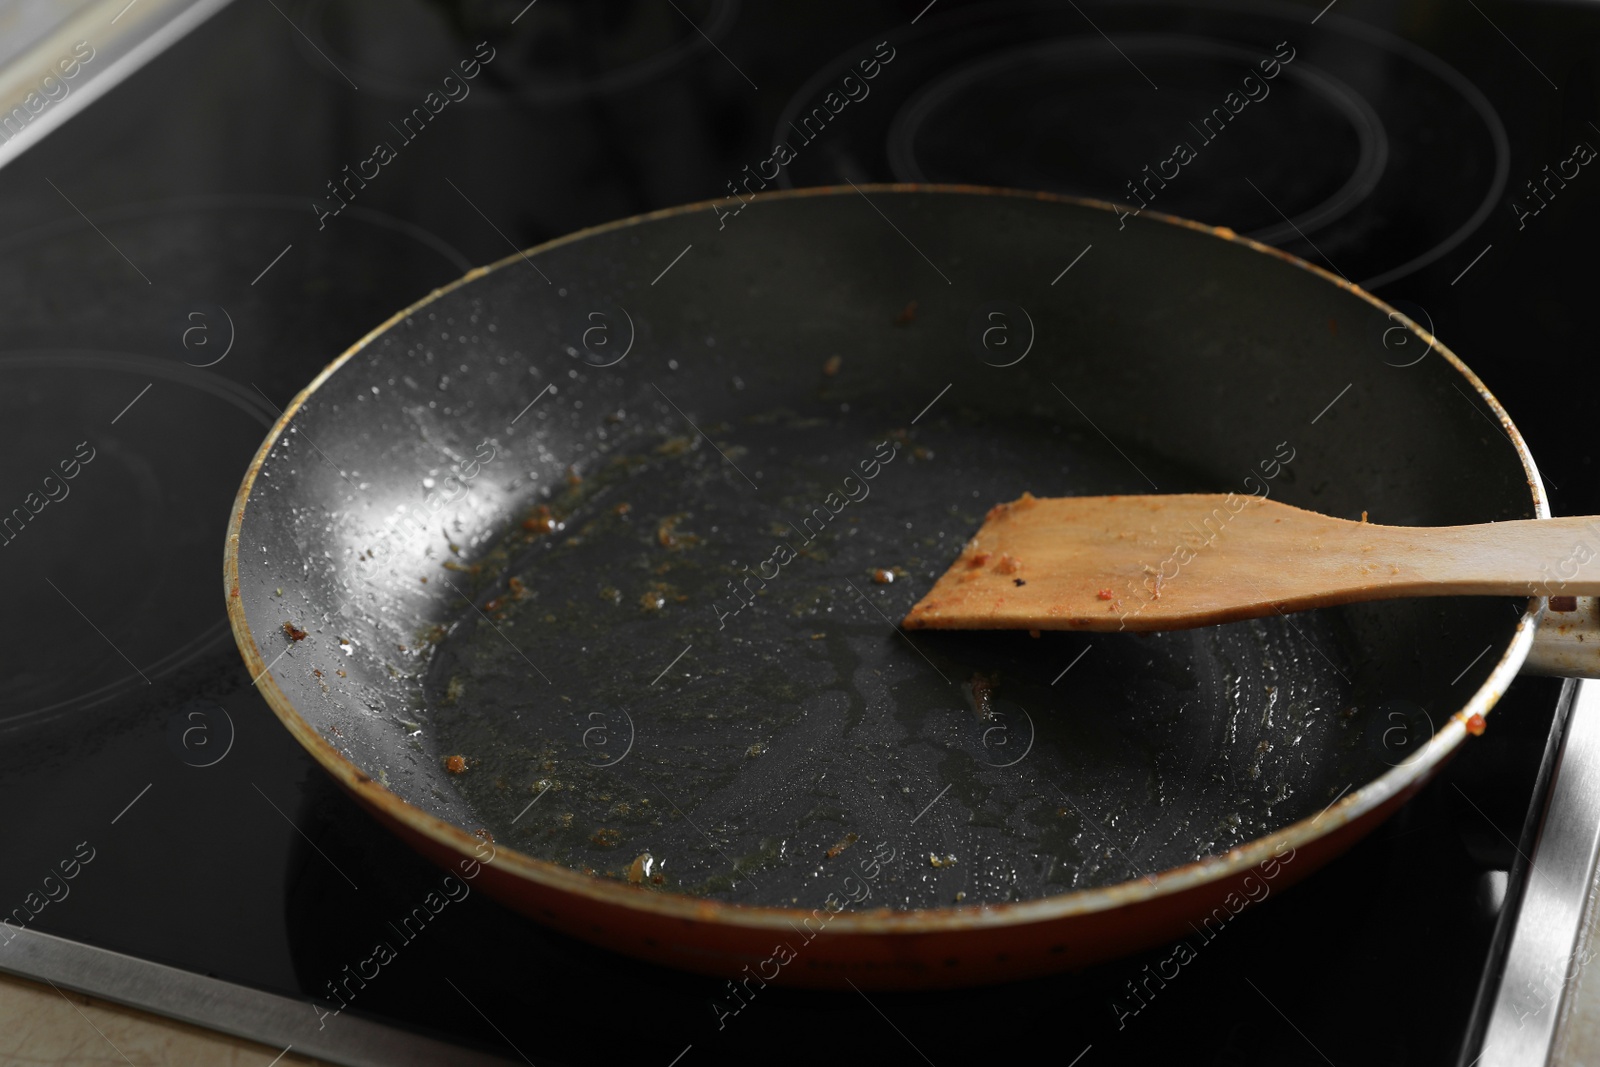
[1474, 681, 1600, 1067]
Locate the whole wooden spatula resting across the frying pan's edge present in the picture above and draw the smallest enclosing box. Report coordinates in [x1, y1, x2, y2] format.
[904, 493, 1600, 630]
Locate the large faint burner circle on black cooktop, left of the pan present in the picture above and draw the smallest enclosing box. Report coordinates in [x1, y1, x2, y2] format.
[0, 197, 467, 729]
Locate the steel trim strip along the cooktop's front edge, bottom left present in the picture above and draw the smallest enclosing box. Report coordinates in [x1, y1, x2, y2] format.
[0, 926, 512, 1067]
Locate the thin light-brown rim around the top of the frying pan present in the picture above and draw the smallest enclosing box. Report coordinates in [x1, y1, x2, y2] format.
[222, 182, 1550, 936]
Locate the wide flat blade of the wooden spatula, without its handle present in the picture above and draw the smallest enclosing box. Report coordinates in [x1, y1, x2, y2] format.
[902, 493, 1395, 630]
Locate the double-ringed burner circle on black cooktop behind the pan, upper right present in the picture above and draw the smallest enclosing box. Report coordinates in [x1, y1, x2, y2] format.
[787, 0, 1510, 288]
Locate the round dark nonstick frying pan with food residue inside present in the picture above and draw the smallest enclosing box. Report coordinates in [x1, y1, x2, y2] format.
[224, 186, 1568, 989]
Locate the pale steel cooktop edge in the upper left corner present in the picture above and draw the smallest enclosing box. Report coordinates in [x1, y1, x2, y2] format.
[0, 0, 230, 166]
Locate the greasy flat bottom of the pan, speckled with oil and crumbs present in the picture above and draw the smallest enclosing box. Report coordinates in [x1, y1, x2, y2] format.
[426, 397, 1381, 909]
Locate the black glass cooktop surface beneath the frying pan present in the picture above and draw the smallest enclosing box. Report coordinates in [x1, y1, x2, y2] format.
[0, 0, 1600, 1067]
